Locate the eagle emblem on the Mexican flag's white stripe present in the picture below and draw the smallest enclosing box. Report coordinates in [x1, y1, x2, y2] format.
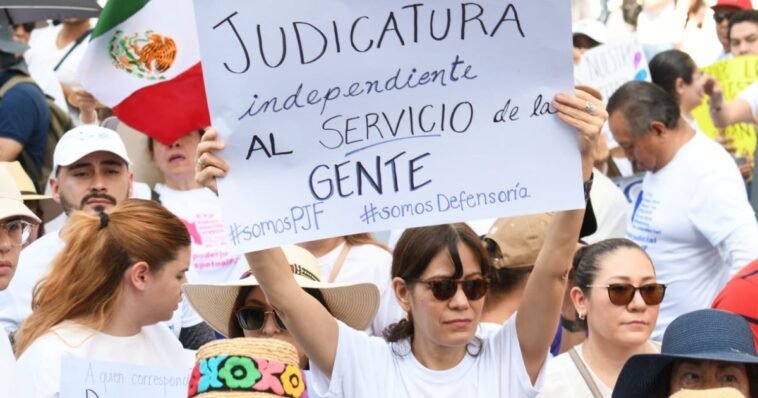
[108, 30, 177, 80]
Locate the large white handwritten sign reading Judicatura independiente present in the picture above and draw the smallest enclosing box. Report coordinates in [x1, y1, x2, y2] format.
[195, 0, 584, 252]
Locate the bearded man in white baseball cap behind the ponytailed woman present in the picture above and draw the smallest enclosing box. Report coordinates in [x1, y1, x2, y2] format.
[0, 125, 212, 348]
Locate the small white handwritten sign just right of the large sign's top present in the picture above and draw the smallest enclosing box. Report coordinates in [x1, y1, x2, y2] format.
[574, 39, 650, 102]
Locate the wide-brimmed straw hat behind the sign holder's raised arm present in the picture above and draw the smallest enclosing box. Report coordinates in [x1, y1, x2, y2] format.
[184, 245, 379, 336]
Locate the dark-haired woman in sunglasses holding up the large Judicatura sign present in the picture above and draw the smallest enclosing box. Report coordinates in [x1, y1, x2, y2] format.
[196, 90, 607, 398]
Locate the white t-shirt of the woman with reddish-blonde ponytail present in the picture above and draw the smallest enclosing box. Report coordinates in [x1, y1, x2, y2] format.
[16, 321, 194, 398]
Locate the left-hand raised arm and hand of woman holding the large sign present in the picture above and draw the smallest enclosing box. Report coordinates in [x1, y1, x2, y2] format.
[195, 129, 339, 377]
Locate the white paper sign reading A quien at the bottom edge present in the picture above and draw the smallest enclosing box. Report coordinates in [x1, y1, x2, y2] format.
[60, 356, 192, 398]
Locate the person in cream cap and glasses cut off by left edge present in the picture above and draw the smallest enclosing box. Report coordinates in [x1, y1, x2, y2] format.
[0, 167, 40, 397]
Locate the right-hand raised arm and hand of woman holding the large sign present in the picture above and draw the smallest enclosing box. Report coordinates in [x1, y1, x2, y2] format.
[516, 90, 608, 383]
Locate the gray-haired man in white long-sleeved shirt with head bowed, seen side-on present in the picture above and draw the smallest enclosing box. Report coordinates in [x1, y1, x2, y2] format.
[608, 81, 758, 340]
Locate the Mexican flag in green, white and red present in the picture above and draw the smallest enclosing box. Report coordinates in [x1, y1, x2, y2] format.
[79, 0, 210, 144]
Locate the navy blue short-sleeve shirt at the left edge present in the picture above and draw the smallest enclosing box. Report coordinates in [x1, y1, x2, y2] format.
[0, 71, 50, 167]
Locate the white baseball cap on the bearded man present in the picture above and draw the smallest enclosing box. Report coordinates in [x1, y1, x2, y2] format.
[53, 124, 132, 172]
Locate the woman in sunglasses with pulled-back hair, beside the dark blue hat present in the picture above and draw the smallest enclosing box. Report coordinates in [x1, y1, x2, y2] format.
[540, 239, 666, 398]
